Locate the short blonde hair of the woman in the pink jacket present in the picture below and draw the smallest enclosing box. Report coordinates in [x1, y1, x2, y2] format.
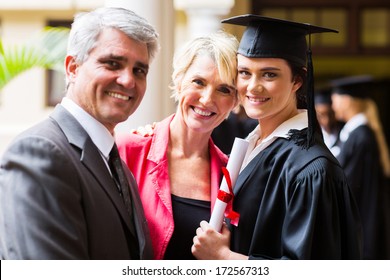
[170, 31, 238, 101]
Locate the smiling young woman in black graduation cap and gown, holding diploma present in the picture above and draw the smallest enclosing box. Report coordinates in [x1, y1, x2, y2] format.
[192, 15, 362, 259]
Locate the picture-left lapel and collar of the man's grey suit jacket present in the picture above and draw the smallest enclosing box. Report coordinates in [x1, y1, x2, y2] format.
[51, 105, 134, 233]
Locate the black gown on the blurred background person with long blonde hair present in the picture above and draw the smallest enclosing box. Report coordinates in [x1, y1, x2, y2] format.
[337, 125, 390, 259]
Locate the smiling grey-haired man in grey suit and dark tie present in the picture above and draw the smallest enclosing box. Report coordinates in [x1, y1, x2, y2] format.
[0, 8, 159, 259]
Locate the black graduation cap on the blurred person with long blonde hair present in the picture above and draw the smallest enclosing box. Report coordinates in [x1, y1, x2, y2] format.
[330, 75, 374, 98]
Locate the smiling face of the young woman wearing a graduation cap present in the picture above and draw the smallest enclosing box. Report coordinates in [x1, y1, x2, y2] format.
[237, 55, 302, 125]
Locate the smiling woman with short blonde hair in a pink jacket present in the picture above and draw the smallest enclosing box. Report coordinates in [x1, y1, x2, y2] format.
[117, 32, 238, 259]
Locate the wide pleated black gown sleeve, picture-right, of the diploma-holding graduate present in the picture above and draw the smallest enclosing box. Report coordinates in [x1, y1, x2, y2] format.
[282, 159, 359, 259]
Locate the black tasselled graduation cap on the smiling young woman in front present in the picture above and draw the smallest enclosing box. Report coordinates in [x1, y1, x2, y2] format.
[222, 14, 338, 148]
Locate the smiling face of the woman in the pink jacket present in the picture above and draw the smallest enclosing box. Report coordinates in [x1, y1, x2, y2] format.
[177, 55, 237, 133]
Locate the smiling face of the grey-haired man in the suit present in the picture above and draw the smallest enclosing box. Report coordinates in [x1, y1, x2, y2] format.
[66, 29, 149, 133]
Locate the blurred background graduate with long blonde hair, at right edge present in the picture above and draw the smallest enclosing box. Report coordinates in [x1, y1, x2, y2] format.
[332, 76, 390, 259]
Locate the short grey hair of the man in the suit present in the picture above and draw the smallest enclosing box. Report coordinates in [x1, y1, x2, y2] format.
[67, 7, 160, 63]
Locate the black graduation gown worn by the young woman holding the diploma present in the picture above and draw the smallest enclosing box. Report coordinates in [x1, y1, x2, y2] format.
[230, 135, 362, 259]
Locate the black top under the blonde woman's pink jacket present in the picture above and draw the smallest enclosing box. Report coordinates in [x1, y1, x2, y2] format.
[164, 194, 211, 260]
